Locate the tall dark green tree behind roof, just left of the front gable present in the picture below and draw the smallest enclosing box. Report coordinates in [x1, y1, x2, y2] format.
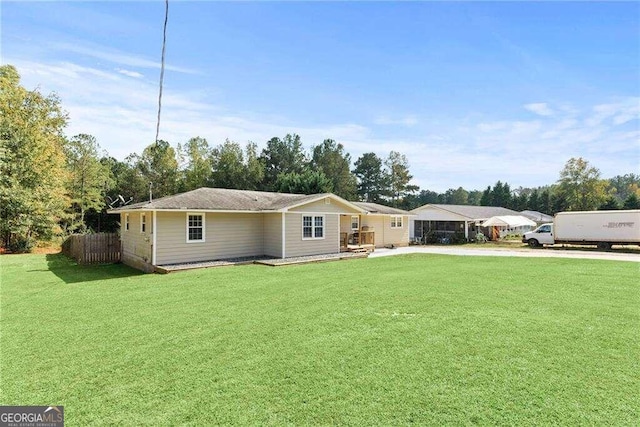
[260, 134, 308, 191]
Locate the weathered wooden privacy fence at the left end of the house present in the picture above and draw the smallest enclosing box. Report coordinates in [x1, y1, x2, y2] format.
[62, 233, 120, 264]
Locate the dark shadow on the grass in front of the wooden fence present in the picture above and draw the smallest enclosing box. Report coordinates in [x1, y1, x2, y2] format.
[46, 253, 144, 283]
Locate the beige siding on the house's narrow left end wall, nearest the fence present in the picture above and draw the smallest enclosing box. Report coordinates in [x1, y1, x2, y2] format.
[120, 212, 153, 267]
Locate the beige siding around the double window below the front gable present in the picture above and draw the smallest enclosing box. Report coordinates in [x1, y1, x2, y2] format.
[285, 213, 340, 258]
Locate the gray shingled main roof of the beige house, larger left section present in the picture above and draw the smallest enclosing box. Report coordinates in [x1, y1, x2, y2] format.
[110, 187, 330, 212]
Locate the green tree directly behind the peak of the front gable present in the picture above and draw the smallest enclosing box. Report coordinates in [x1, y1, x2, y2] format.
[311, 139, 357, 200]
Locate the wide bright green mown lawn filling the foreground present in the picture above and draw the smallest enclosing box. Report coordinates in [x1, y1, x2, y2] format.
[0, 254, 640, 426]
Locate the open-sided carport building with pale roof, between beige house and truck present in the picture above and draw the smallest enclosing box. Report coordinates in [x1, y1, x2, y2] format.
[409, 204, 519, 241]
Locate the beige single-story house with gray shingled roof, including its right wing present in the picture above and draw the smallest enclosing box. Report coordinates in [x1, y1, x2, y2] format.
[109, 188, 409, 271]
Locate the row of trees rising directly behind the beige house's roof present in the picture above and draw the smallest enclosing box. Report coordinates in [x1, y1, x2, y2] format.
[111, 134, 417, 206]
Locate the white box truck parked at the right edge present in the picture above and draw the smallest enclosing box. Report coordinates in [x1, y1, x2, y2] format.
[522, 209, 640, 249]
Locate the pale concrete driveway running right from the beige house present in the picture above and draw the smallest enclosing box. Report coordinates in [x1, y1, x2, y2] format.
[369, 246, 640, 262]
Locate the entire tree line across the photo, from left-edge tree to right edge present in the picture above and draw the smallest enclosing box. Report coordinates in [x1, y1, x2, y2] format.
[0, 65, 640, 251]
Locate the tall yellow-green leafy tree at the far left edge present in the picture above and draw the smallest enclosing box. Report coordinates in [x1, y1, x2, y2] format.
[0, 65, 68, 251]
